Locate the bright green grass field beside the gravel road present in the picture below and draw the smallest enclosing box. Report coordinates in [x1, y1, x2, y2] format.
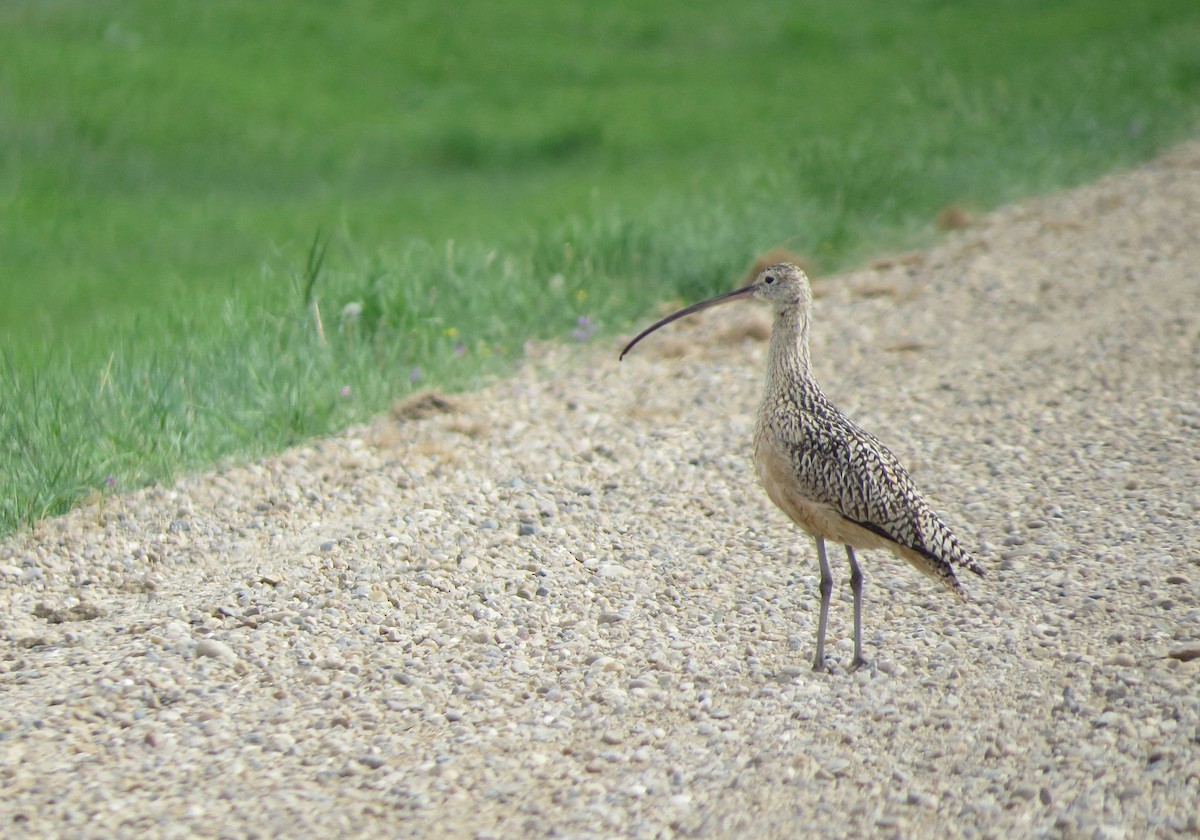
[0, 0, 1200, 533]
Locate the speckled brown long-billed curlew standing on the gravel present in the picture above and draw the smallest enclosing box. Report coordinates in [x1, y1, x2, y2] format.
[620, 263, 983, 671]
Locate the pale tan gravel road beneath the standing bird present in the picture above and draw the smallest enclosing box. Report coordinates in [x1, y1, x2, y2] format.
[7, 144, 1200, 838]
